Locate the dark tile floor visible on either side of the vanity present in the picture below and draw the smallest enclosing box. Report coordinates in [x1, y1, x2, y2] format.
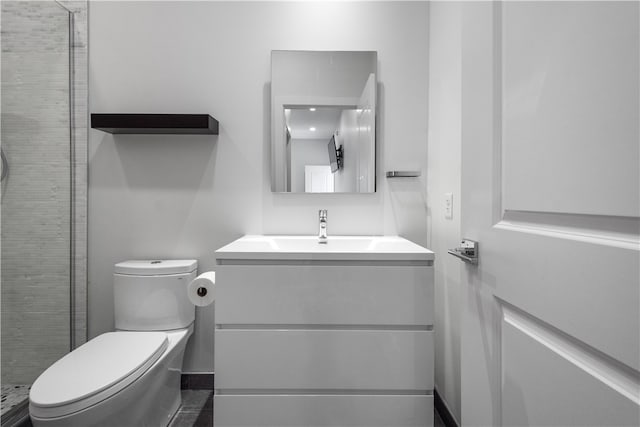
[169, 390, 445, 427]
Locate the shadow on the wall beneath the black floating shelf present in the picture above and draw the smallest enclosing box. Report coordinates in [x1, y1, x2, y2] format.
[91, 134, 218, 190]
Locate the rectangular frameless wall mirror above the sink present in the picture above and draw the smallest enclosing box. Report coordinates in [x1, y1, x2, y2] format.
[271, 50, 377, 193]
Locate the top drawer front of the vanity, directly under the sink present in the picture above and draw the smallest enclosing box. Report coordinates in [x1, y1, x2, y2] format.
[215, 265, 433, 325]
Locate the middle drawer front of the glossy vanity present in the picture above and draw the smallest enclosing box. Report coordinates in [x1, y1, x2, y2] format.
[214, 329, 433, 391]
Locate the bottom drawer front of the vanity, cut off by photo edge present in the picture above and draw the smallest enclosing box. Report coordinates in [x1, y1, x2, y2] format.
[213, 395, 433, 427]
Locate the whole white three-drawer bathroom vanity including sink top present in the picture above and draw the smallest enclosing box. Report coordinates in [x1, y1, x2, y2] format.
[214, 236, 434, 427]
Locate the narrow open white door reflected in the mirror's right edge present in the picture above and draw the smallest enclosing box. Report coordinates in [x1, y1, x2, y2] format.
[356, 74, 376, 193]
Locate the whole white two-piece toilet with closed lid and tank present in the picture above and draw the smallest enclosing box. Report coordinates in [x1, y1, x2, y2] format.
[29, 260, 197, 427]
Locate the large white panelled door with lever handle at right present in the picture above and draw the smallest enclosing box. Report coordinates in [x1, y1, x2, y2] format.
[461, 2, 640, 426]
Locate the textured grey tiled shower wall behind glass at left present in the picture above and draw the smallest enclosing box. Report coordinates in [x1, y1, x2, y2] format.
[1, 1, 86, 384]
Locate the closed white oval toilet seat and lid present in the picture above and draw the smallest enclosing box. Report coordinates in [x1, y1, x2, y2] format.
[29, 331, 168, 418]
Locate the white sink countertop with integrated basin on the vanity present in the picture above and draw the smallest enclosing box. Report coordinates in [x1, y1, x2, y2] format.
[216, 235, 433, 261]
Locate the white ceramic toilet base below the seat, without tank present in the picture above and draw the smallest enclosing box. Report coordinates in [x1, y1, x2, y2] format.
[31, 325, 193, 427]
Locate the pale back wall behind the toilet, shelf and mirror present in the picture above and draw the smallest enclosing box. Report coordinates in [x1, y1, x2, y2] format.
[89, 2, 428, 372]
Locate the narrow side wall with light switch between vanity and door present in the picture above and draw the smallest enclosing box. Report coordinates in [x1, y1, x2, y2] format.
[427, 2, 462, 424]
